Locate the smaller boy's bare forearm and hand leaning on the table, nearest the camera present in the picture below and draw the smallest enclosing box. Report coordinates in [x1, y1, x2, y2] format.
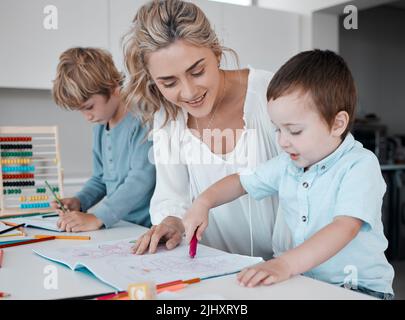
[237, 216, 363, 287]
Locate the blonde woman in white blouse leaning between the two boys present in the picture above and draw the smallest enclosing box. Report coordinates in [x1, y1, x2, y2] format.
[124, 0, 290, 258]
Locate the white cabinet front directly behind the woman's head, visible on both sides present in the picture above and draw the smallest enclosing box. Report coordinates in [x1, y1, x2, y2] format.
[109, 0, 301, 71]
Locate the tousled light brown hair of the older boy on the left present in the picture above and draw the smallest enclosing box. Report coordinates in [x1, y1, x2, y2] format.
[52, 47, 123, 110]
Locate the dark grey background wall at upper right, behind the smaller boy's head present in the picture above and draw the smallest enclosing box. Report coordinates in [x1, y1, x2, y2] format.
[340, 7, 405, 134]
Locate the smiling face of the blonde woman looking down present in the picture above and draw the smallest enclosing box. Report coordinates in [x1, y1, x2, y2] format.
[147, 40, 223, 118]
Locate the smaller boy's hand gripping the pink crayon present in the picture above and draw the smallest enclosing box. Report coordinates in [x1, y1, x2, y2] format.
[183, 198, 210, 243]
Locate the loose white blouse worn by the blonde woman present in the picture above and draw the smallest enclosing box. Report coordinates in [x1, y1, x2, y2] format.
[150, 68, 291, 259]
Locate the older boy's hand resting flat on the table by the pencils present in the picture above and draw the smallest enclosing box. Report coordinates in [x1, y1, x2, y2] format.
[57, 211, 103, 232]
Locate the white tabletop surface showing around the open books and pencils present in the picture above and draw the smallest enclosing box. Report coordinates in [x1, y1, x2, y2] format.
[0, 222, 372, 300]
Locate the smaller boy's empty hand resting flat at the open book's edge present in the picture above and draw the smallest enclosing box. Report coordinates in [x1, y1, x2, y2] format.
[237, 257, 293, 287]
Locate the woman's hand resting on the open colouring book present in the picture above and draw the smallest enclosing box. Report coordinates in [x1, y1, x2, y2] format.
[132, 216, 184, 254]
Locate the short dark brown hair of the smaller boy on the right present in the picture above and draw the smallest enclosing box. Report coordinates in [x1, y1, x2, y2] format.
[267, 49, 357, 139]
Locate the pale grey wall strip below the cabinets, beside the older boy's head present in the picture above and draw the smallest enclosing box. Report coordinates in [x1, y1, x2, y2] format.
[0, 88, 92, 178]
